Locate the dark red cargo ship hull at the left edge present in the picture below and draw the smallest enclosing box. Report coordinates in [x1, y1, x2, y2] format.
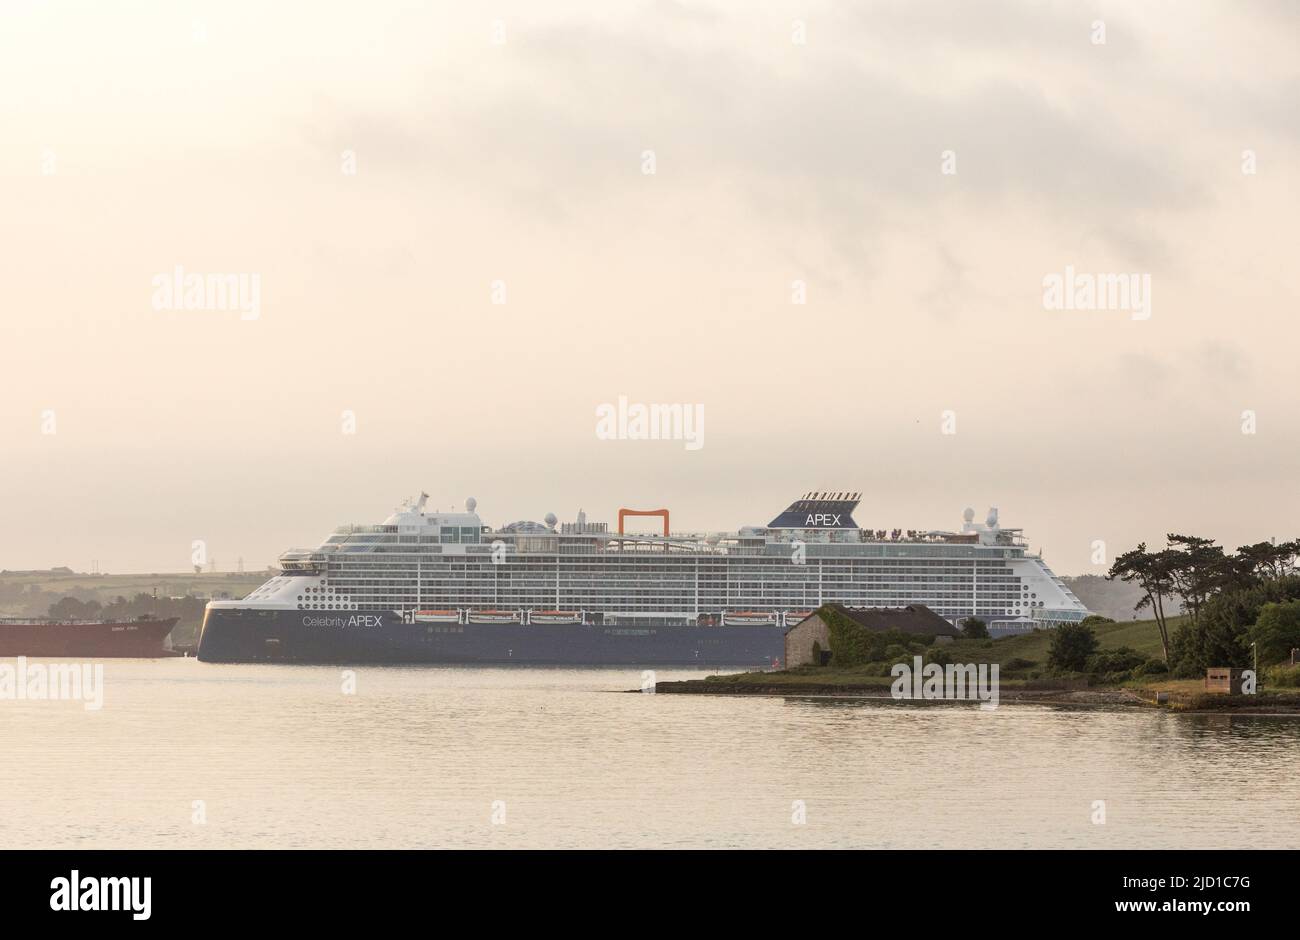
[0, 616, 179, 659]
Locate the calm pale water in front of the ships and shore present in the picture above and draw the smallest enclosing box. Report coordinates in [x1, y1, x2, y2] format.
[0, 659, 1300, 848]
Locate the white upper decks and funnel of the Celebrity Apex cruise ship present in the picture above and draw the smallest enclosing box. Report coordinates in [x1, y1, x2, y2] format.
[212, 493, 1088, 632]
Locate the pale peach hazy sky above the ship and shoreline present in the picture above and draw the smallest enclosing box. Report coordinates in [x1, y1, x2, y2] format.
[0, 0, 1300, 575]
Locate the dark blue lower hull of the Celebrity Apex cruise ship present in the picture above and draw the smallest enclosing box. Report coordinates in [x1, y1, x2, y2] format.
[199, 608, 785, 667]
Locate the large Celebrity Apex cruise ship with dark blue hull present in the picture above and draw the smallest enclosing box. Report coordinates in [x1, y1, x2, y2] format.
[199, 493, 1088, 667]
